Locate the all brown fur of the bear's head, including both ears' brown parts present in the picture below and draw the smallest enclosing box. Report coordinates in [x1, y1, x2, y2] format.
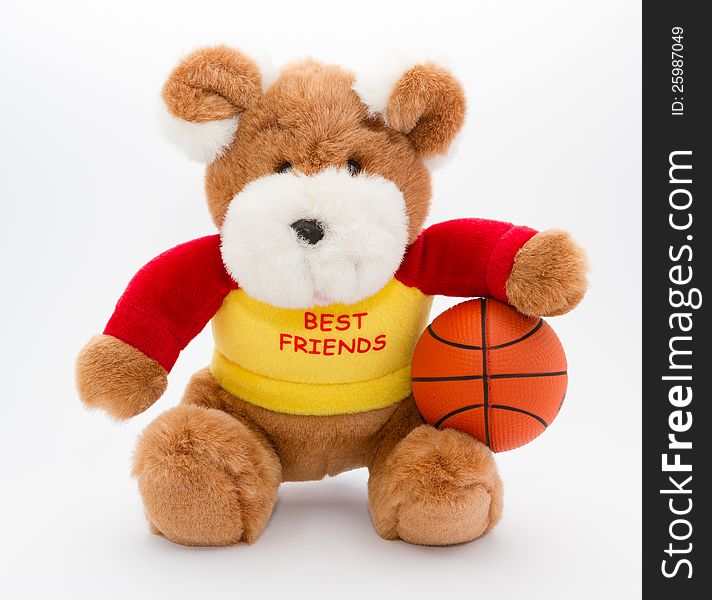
[163, 46, 465, 241]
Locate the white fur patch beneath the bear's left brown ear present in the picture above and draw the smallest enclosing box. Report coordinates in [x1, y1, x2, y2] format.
[159, 103, 239, 164]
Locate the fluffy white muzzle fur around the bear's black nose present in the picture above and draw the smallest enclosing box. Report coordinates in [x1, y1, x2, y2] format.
[220, 169, 408, 308]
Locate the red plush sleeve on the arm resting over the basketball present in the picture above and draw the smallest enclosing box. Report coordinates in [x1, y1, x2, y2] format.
[395, 219, 537, 302]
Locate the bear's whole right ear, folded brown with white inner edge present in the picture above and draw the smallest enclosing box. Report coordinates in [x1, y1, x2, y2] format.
[353, 62, 465, 158]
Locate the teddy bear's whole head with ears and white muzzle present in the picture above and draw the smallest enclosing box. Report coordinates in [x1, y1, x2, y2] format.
[163, 46, 465, 308]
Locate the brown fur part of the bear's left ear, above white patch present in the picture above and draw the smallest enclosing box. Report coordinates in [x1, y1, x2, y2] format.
[162, 46, 262, 123]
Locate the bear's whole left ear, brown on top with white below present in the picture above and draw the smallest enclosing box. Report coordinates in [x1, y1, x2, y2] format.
[161, 46, 262, 163]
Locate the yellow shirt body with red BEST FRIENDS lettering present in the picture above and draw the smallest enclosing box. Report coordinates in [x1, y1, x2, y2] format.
[210, 279, 432, 415]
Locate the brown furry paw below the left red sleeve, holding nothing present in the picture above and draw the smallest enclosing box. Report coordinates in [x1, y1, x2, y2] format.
[76, 335, 168, 420]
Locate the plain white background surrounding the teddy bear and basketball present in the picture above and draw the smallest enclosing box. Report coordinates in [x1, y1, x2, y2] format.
[0, 0, 641, 599]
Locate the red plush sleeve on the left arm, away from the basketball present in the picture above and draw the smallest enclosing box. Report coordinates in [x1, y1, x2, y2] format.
[104, 235, 237, 371]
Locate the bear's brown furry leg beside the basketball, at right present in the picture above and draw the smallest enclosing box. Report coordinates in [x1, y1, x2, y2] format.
[368, 400, 502, 546]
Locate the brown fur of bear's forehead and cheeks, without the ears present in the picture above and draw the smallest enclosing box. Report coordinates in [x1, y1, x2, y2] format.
[205, 60, 431, 241]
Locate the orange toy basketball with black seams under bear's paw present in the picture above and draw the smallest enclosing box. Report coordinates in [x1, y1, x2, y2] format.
[412, 298, 567, 452]
